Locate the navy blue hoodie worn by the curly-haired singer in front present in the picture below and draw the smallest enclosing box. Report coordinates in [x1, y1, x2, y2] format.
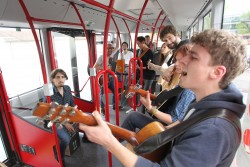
[135, 84, 246, 167]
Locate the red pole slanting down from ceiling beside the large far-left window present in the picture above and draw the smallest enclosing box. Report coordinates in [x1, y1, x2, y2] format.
[19, 0, 48, 84]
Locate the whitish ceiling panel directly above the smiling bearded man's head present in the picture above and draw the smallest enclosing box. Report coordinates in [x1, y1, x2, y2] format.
[157, 0, 210, 31]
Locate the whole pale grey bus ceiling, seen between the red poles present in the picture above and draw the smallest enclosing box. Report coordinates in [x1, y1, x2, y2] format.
[0, 0, 211, 32]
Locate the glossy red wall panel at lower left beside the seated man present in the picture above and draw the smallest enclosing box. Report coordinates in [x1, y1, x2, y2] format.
[12, 115, 60, 167]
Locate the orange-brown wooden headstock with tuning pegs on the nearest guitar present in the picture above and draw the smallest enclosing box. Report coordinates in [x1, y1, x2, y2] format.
[33, 102, 96, 127]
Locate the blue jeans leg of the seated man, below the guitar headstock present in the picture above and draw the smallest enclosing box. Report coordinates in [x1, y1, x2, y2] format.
[56, 126, 70, 160]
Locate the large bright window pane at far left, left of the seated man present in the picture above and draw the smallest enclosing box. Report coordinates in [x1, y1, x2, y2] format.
[0, 28, 44, 97]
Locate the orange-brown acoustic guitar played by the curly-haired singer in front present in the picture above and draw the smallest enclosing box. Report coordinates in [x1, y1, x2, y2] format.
[33, 102, 171, 162]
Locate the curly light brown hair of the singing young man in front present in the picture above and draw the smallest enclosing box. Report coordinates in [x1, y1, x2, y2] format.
[191, 29, 247, 89]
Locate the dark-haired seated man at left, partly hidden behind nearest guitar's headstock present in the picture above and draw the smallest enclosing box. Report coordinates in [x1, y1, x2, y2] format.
[50, 68, 75, 166]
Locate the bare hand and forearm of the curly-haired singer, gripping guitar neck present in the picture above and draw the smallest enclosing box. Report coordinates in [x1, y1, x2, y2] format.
[79, 111, 138, 167]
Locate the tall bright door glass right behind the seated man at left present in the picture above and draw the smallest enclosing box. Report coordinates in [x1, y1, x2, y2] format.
[52, 30, 92, 101]
